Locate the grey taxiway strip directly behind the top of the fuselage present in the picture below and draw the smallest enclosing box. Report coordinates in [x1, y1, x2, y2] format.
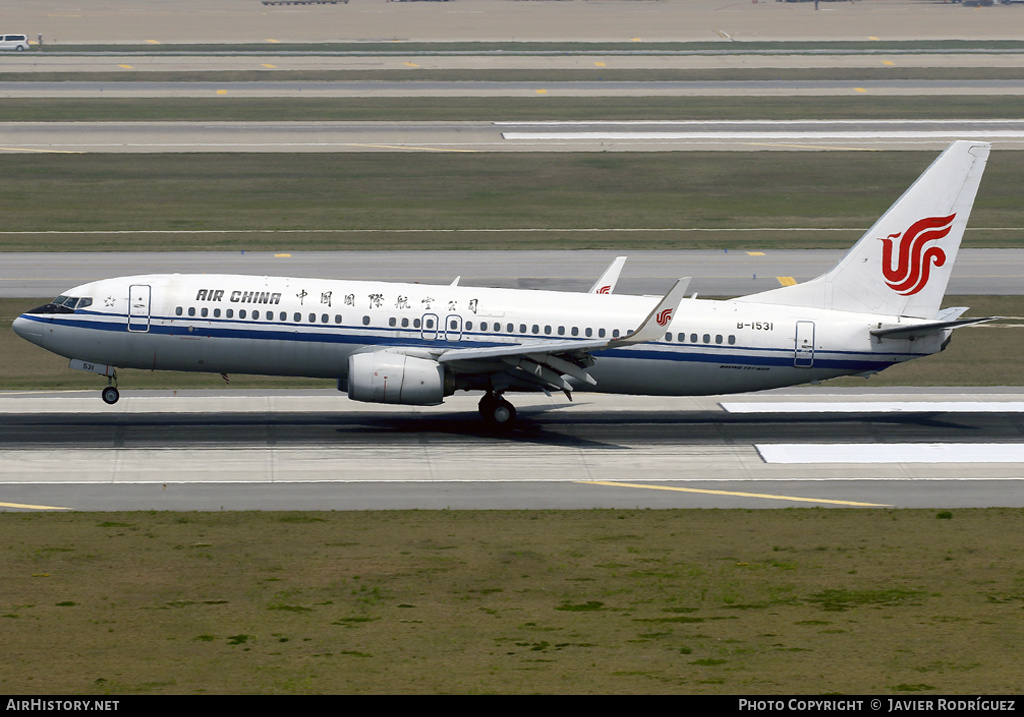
[0, 248, 1024, 298]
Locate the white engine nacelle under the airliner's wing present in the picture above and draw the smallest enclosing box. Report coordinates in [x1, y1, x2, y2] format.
[348, 351, 455, 406]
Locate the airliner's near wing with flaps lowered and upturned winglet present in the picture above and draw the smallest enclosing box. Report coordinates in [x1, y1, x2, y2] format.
[437, 278, 690, 395]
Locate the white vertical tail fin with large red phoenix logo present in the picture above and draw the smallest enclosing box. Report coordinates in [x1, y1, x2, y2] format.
[738, 140, 990, 319]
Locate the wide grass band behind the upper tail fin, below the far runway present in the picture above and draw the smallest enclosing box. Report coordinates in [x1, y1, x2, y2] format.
[0, 152, 1024, 251]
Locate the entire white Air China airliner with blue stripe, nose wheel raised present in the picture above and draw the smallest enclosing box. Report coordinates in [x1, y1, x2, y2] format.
[14, 141, 989, 425]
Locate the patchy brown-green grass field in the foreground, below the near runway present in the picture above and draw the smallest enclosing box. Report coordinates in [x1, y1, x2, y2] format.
[0, 509, 1024, 694]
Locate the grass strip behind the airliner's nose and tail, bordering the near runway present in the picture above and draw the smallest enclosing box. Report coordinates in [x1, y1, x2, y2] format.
[8, 296, 1024, 391]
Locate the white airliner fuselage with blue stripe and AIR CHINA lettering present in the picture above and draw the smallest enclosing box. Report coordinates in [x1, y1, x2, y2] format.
[15, 275, 948, 395]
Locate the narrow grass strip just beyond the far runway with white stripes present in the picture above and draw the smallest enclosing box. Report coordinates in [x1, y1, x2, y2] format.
[0, 95, 1020, 122]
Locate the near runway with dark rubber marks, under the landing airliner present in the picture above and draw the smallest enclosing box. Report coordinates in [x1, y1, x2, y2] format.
[0, 388, 1024, 510]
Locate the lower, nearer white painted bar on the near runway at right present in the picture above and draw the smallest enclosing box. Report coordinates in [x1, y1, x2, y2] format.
[755, 444, 1024, 465]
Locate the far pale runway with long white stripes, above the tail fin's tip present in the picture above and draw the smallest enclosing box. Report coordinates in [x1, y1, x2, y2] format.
[6, 118, 1024, 154]
